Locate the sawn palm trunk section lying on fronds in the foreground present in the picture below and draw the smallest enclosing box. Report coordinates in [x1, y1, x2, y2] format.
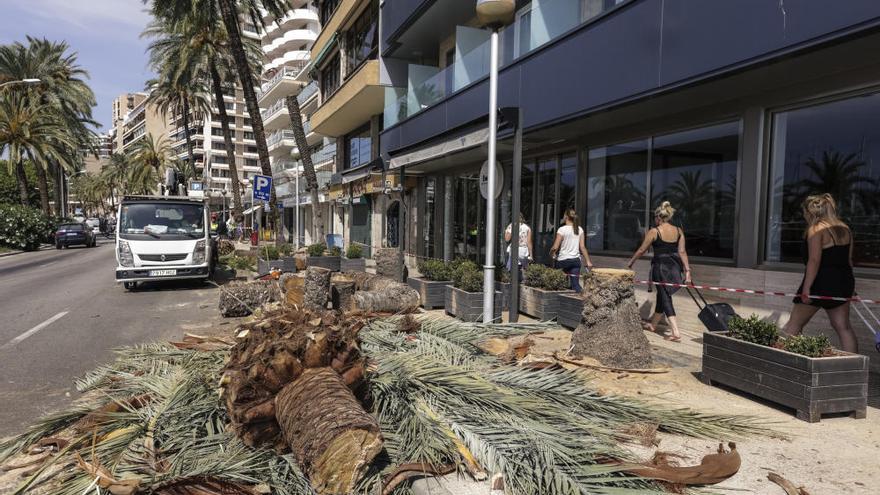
[275, 368, 382, 495]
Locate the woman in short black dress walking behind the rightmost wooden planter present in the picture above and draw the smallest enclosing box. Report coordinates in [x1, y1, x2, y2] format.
[782, 194, 858, 353]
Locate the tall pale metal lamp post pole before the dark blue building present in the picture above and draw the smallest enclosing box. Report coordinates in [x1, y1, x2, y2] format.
[483, 29, 498, 323]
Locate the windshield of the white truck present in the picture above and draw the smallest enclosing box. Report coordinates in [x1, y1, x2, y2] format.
[119, 202, 205, 238]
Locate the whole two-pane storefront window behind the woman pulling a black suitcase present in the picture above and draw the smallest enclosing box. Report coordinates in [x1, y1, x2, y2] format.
[587, 122, 739, 259]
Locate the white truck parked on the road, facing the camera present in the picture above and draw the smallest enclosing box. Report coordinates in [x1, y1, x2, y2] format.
[116, 196, 217, 290]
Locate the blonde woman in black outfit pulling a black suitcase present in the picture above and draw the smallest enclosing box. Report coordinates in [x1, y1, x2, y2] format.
[627, 201, 691, 342]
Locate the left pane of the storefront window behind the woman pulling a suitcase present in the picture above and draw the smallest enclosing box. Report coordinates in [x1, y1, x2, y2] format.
[586, 140, 648, 251]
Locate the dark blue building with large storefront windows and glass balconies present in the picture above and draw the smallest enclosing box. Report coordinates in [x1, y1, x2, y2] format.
[380, 0, 880, 380]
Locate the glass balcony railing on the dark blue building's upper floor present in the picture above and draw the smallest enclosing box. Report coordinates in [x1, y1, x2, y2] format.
[384, 0, 631, 128]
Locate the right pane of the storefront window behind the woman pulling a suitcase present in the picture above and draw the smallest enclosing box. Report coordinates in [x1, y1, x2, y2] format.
[650, 122, 739, 259]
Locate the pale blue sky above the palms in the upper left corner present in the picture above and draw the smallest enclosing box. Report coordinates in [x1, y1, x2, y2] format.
[0, 0, 151, 132]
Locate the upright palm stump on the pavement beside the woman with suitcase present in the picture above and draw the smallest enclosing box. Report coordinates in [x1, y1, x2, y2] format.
[571, 269, 651, 368]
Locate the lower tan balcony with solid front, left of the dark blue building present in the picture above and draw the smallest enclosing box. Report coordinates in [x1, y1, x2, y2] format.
[311, 59, 385, 137]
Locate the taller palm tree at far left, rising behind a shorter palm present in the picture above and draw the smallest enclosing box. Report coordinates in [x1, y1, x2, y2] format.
[0, 37, 97, 214]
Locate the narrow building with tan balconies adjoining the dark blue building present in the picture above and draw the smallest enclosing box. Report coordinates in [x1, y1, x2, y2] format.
[311, 0, 386, 251]
